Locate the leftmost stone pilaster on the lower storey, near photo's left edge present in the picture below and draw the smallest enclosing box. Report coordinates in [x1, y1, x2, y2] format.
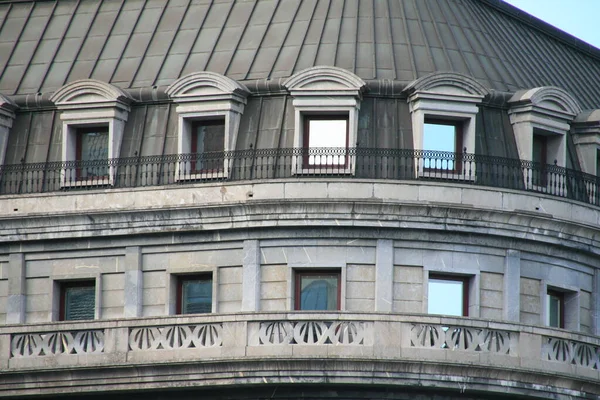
[6, 253, 26, 324]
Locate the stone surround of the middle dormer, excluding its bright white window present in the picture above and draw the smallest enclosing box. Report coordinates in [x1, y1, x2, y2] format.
[283, 66, 366, 175]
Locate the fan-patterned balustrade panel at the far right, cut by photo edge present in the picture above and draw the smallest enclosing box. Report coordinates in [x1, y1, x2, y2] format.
[542, 337, 600, 370]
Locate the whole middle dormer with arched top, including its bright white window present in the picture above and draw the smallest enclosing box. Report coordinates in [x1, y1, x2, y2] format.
[284, 66, 366, 174]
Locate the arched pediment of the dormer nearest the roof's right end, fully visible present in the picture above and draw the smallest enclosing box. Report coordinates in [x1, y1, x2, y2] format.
[509, 86, 581, 116]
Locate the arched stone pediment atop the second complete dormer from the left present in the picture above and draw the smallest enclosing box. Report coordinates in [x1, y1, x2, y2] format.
[166, 71, 250, 101]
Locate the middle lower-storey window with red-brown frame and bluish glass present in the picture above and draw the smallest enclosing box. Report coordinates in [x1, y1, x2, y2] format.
[294, 271, 341, 310]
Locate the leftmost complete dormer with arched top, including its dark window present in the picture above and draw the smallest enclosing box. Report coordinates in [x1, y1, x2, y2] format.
[50, 79, 131, 187]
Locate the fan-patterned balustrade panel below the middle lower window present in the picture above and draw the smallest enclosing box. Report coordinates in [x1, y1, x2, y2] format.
[258, 321, 373, 346]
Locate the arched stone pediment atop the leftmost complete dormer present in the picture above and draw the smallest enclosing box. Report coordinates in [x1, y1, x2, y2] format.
[50, 79, 132, 107]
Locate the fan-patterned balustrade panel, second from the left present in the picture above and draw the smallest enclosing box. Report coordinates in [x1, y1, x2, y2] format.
[129, 324, 223, 351]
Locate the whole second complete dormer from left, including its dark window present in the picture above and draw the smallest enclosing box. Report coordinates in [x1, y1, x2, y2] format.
[166, 72, 249, 181]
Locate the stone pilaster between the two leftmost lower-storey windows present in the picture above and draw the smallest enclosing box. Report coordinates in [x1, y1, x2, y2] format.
[123, 246, 143, 318]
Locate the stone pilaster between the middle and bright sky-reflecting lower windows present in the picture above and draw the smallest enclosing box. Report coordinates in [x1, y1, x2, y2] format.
[375, 239, 394, 312]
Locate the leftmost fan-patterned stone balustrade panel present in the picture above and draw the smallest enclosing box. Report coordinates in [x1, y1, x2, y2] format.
[10, 330, 104, 357]
